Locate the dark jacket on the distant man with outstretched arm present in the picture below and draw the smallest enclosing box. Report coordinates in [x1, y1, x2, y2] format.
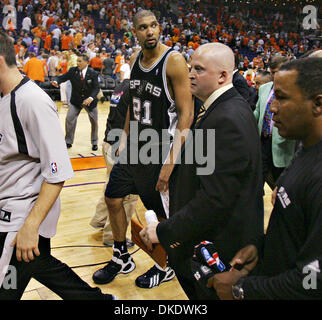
[57, 67, 100, 109]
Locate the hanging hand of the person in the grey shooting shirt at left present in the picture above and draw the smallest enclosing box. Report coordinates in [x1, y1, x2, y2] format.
[11, 222, 40, 262]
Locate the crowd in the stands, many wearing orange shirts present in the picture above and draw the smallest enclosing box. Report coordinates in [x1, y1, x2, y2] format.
[0, 0, 321, 94]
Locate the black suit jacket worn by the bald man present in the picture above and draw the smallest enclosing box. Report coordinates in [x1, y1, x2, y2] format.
[157, 88, 264, 293]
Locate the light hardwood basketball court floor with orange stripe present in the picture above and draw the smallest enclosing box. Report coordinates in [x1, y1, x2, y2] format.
[22, 102, 272, 300]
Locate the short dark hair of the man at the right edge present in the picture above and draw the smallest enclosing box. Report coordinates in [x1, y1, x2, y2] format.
[279, 57, 322, 99]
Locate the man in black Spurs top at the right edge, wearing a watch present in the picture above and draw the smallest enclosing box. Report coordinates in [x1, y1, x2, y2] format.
[208, 58, 322, 300]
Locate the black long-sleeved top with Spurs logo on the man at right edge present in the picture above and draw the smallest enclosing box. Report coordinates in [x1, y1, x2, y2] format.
[244, 141, 322, 299]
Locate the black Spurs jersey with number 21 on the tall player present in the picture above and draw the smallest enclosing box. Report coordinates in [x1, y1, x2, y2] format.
[130, 48, 177, 142]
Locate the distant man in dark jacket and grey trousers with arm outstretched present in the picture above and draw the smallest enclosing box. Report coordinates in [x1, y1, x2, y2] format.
[51, 54, 100, 151]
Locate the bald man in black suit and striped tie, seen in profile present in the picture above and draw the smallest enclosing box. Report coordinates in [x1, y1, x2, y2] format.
[141, 43, 264, 299]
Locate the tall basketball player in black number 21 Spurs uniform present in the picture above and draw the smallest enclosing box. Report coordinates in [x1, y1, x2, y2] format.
[93, 10, 193, 288]
